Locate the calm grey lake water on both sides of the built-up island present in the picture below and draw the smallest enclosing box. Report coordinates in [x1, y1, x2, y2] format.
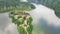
[0, 3, 60, 34]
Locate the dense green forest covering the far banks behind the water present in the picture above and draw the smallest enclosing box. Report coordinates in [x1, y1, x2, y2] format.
[0, 0, 60, 17]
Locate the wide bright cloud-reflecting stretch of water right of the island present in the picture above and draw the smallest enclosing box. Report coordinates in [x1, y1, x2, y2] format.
[31, 4, 60, 34]
